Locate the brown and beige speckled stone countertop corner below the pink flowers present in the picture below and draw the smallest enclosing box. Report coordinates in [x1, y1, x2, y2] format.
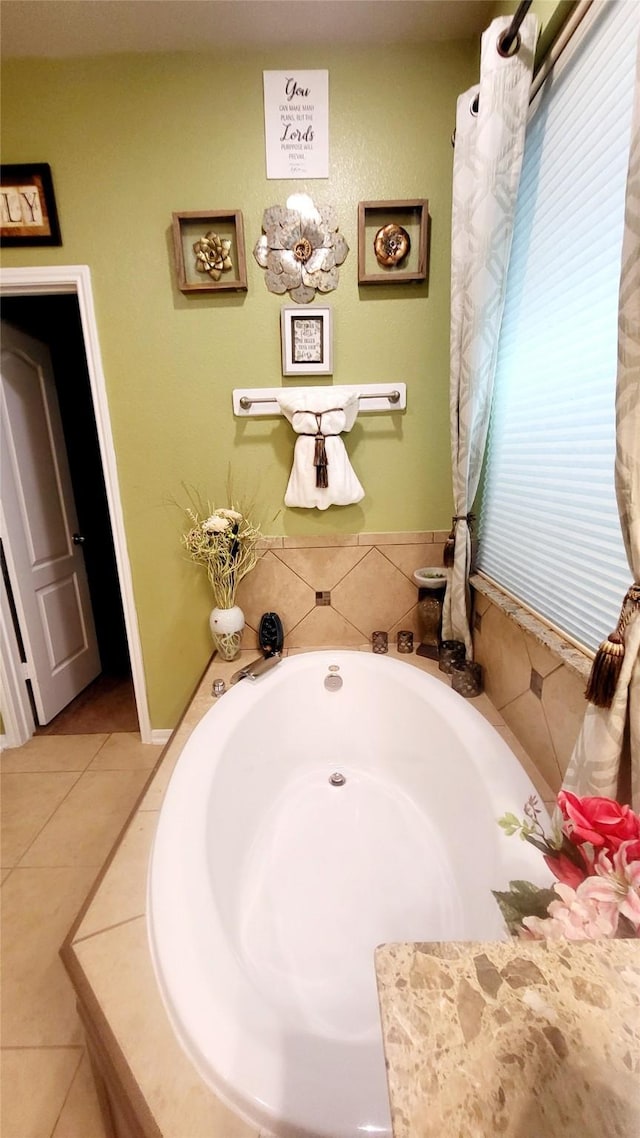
[376, 940, 640, 1138]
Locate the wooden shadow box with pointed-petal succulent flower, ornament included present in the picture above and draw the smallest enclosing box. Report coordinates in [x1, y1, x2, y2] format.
[173, 209, 247, 292]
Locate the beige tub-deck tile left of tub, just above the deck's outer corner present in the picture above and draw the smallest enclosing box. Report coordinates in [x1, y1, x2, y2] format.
[76, 810, 158, 940]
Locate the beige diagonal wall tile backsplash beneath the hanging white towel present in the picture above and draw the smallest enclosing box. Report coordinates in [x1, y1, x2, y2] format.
[237, 530, 448, 649]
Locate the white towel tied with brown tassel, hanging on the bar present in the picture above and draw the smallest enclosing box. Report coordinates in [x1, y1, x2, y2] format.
[277, 387, 364, 510]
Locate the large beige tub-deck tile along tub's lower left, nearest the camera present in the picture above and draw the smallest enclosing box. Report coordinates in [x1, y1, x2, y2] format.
[75, 918, 259, 1138]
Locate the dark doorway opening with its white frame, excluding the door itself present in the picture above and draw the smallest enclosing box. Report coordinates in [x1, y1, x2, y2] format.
[2, 266, 151, 745]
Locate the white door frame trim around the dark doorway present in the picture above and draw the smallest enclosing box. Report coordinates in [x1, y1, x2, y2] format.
[0, 265, 153, 747]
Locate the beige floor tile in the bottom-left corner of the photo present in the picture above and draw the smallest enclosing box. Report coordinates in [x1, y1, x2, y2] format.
[0, 1047, 82, 1138]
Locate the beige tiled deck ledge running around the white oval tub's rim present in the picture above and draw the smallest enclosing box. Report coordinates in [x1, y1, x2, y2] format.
[57, 643, 552, 1138]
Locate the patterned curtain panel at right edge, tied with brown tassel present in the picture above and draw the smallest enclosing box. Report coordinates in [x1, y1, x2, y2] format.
[563, 35, 640, 811]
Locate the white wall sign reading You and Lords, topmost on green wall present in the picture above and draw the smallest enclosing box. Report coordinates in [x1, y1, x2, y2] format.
[262, 69, 329, 179]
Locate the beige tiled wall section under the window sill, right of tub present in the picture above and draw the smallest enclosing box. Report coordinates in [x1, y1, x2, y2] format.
[473, 576, 591, 792]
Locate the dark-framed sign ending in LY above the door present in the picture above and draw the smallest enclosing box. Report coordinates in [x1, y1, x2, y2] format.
[0, 163, 63, 246]
